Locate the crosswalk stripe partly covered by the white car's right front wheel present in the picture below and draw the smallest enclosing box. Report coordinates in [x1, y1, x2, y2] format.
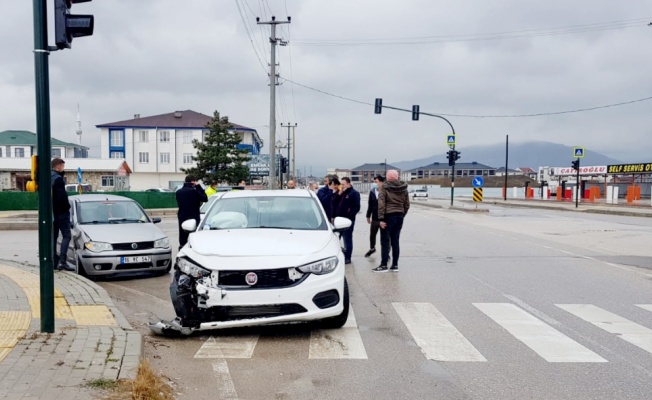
[308, 307, 367, 360]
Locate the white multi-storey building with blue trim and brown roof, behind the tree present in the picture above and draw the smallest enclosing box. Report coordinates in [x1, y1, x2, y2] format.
[97, 110, 263, 190]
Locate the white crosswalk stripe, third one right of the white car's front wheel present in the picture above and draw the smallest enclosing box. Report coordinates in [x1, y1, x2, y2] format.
[473, 303, 607, 362]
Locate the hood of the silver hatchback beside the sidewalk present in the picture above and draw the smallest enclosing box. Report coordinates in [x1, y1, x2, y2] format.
[79, 223, 165, 243]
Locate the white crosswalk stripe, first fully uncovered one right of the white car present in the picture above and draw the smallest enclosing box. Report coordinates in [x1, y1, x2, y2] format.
[392, 303, 487, 361]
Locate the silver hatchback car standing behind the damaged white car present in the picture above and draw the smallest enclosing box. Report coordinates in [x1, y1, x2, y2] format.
[61, 194, 172, 277]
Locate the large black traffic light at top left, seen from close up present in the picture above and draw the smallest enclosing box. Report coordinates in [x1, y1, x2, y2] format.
[54, 0, 95, 49]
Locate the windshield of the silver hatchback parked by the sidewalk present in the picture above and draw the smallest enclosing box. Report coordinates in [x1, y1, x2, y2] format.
[77, 201, 149, 224]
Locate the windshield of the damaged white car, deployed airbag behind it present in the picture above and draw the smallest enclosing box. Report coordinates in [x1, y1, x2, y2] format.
[203, 196, 328, 230]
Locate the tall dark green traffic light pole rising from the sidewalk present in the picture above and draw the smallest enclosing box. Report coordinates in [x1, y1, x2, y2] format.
[33, 0, 54, 333]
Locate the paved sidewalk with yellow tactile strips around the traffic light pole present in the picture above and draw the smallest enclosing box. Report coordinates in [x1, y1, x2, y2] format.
[0, 261, 143, 400]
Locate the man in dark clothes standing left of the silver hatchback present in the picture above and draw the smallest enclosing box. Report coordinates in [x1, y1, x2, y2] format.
[50, 158, 75, 271]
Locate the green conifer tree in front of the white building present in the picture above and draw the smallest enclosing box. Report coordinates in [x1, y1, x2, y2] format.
[181, 111, 249, 185]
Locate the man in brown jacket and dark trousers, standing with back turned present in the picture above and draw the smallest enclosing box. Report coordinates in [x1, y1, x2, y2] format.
[373, 169, 410, 272]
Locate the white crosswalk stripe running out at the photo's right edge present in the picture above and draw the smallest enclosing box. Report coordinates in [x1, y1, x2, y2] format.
[556, 304, 652, 353]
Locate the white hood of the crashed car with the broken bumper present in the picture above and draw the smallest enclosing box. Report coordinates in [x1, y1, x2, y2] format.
[189, 229, 334, 257]
